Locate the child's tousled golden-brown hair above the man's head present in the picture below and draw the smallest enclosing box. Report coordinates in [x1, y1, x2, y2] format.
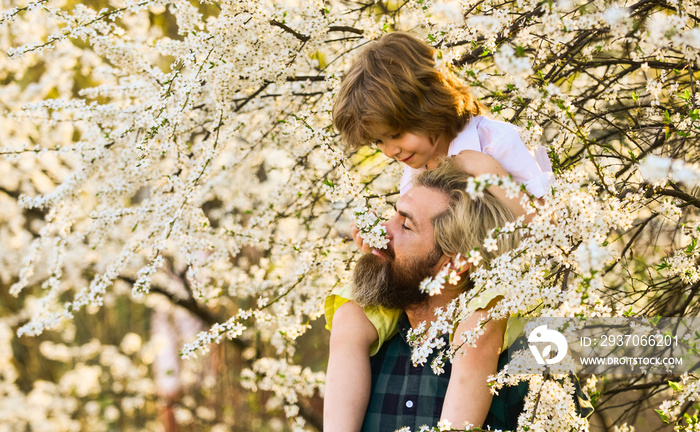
[333, 32, 485, 149]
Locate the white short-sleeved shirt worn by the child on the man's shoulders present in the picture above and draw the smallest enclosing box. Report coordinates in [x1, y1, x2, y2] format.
[400, 116, 554, 198]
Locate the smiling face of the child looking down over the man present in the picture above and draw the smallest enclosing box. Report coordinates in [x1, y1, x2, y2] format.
[375, 126, 437, 168]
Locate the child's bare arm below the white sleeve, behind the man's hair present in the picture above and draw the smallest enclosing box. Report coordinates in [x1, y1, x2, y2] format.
[455, 150, 534, 222]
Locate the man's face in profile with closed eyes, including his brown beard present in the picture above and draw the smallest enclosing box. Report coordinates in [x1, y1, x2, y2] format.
[353, 186, 447, 309]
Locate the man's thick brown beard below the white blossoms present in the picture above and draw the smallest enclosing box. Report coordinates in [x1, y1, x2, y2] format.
[353, 248, 442, 309]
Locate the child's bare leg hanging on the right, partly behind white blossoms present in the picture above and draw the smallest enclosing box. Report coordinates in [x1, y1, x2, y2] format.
[441, 302, 507, 429]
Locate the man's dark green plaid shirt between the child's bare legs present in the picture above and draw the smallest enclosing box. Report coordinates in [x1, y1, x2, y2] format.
[362, 315, 527, 432]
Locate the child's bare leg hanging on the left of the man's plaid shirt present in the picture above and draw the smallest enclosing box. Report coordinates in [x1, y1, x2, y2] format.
[323, 301, 379, 432]
